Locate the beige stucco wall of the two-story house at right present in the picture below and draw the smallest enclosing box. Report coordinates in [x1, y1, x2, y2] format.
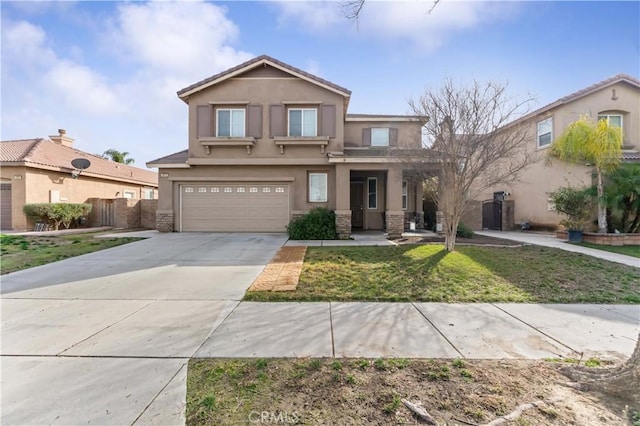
[478, 83, 640, 229]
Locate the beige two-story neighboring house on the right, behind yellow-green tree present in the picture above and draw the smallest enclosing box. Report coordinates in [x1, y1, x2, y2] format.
[472, 74, 640, 230]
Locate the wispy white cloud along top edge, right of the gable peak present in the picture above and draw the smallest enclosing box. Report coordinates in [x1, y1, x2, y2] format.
[277, 0, 519, 51]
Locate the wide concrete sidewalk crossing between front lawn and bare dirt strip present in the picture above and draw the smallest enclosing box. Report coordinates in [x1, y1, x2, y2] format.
[194, 302, 640, 361]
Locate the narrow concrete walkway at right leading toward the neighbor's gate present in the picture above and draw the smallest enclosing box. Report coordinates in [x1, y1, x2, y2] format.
[476, 231, 640, 268]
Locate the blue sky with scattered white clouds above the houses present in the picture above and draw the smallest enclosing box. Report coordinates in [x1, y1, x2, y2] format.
[0, 0, 640, 167]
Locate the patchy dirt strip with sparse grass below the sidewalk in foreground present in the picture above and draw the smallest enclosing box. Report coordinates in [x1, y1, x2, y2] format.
[187, 359, 628, 426]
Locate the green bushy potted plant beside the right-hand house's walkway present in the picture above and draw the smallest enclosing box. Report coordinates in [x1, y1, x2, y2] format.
[549, 186, 593, 243]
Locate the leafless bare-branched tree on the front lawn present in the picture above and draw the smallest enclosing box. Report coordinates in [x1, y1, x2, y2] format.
[404, 80, 538, 251]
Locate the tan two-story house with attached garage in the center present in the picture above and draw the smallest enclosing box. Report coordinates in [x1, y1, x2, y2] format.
[147, 56, 424, 238]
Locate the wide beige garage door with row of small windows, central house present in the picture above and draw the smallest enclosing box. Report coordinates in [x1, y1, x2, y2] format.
[180, 182, 289, 232]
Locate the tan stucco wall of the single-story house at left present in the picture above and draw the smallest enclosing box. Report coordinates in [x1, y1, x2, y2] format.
[0, 166, 157, 230]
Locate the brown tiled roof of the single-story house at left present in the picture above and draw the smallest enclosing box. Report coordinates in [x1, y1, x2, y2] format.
[0, 138, 158, 187]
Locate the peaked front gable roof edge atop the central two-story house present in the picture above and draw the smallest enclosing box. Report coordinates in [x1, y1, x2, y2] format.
[178, 55, 351, 102]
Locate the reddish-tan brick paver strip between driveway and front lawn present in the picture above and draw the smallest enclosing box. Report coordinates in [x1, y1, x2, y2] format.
[249, 246, 307, 291]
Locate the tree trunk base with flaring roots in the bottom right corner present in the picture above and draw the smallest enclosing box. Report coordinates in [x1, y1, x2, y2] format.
[561, 334, 640, 411]
